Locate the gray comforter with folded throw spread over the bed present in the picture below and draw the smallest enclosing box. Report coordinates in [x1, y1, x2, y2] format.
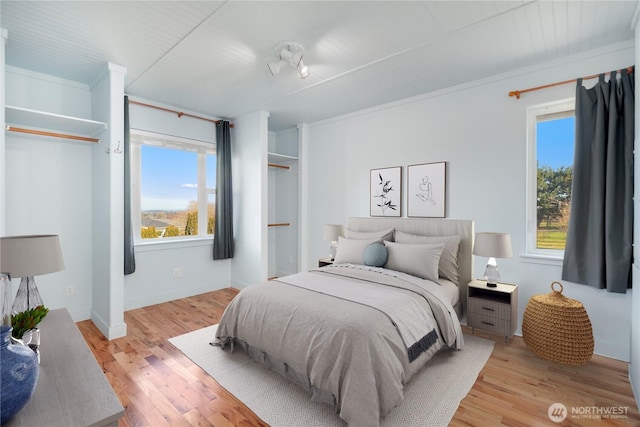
[216, 265, 463, 426]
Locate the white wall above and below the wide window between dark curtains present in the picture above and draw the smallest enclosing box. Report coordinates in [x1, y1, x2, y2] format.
[124, 97, 231, 310]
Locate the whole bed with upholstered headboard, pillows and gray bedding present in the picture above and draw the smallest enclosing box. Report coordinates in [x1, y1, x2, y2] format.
[215, 218, 474, 427]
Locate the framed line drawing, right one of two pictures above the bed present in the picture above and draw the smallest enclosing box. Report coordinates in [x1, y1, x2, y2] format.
[407, 162, 447, 218]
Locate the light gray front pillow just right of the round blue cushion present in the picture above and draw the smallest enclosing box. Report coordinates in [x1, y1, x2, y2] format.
[384, 241, 444, 283]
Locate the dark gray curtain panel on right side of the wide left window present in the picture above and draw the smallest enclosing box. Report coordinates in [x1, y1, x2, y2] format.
[213, 120, 233, 259]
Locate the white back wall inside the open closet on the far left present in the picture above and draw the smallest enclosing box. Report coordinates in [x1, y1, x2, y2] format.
[4, 67, 96, 320]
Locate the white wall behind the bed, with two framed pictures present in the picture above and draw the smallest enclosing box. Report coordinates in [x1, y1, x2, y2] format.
[303, 43, 635, 360]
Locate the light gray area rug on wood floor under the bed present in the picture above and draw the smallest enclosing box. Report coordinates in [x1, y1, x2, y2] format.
[169, 325, 494, 427]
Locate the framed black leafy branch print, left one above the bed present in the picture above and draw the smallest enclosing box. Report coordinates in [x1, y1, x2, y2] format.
[369, 166, 402, 217]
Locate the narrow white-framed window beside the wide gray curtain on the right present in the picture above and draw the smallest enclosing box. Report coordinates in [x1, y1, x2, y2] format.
[527, 99, 575, 257]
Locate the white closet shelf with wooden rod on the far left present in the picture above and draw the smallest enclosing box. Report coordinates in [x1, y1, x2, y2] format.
[5, 105, 107, 142]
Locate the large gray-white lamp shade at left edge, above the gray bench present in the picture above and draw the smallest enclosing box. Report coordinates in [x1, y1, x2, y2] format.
[0, 235, 64, 277]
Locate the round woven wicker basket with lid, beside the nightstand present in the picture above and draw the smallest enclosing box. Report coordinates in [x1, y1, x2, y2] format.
[522, 282, 593, 365]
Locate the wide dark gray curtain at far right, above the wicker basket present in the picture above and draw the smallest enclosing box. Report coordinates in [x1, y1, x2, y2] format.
[562, 70, 635, 293]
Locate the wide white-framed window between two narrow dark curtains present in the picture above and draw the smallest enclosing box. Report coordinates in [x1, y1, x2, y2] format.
[131, 130, 216, 243]
